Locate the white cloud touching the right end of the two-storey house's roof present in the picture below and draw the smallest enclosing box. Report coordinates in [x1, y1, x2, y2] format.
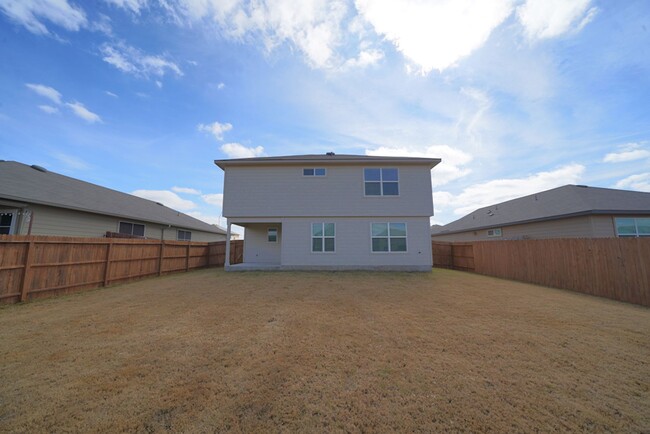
[366, 145, 472, 187]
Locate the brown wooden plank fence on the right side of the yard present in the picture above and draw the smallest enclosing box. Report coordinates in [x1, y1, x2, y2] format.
[432, 238, 650, 306]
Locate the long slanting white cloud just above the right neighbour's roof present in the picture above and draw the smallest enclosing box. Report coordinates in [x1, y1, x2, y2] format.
[433, 164, 585, 216]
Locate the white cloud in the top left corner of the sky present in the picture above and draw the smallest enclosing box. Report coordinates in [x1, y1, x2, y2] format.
[0, 0, 88, 35]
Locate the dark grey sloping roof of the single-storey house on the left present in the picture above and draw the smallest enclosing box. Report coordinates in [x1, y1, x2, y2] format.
[0, 161, 225, 234]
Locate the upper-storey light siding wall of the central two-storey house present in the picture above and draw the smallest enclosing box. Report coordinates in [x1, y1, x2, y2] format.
[223, 163, 433, 217]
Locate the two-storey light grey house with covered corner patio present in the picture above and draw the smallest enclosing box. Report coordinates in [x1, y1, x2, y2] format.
[215, 153, 440, 271]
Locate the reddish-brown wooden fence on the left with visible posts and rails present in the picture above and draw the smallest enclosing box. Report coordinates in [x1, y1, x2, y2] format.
[0, 235, 243, 303]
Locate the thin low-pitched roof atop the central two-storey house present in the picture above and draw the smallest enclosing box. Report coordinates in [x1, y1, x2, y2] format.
[214, 152, 440, 169]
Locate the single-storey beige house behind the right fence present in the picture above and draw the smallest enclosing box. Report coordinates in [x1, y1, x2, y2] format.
[431, 185, 650, 241]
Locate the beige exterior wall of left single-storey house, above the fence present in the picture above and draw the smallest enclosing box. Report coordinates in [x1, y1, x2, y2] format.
[16, 205, 226, 241]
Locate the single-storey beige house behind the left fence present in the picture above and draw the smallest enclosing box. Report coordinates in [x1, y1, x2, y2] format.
[0, 161, 226, 241]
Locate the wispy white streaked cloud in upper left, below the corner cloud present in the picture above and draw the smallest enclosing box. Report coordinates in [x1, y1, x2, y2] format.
[100, 43, 183, 78]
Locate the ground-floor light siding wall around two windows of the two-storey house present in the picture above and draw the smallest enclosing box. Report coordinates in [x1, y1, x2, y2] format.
[278, 217, 432, 271]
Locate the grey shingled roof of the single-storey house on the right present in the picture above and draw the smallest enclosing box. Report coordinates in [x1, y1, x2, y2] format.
[431, 185, 650, 235]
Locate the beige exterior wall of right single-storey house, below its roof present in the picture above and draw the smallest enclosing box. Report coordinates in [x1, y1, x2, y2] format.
[431, 216, 616, 242]
